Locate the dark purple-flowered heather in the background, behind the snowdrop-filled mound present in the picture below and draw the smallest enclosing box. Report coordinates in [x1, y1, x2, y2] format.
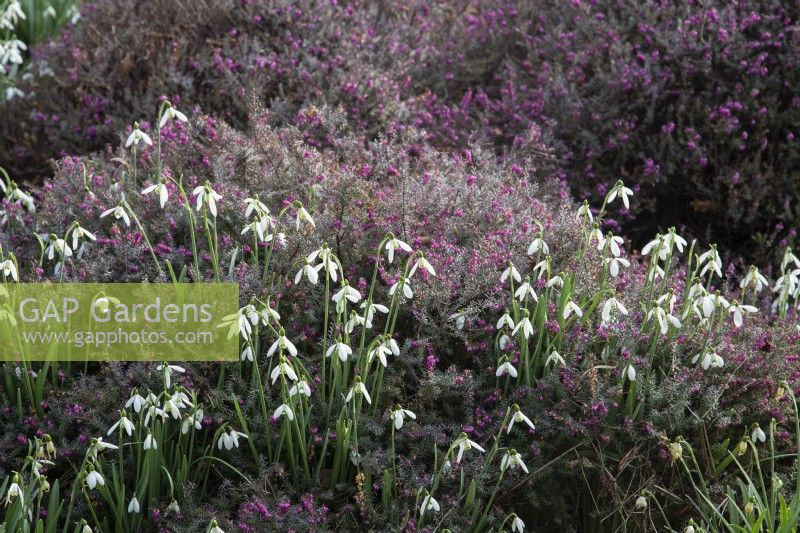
[0, 0, 799, 262]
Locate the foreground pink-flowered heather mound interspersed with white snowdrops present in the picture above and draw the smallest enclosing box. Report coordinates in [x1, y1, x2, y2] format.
[0, 103, 800, 531]
